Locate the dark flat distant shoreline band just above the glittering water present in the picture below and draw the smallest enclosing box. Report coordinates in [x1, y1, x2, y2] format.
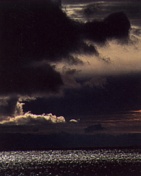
[0, 133, 141, 152]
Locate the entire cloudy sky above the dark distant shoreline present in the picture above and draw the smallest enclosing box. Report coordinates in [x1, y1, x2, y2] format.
[0, 0, 141, 148]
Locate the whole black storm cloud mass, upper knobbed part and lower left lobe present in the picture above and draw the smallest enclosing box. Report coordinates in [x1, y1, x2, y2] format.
[0, 0, 130, 114]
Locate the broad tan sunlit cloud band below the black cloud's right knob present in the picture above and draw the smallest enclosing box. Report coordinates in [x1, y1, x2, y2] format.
[56, 31, 141, 82]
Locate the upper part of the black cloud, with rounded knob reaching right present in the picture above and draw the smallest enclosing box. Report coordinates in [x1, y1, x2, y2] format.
[0, 0, 130, 65]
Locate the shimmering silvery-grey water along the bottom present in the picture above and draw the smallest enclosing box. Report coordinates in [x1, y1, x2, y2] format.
[0, 149, 141, 176]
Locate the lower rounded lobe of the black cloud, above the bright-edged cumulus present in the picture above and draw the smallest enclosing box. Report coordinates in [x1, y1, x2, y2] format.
[0, 64, 63, 96]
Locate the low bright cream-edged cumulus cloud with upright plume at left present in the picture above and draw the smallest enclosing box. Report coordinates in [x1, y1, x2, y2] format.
[0, 98, 66, 125]
